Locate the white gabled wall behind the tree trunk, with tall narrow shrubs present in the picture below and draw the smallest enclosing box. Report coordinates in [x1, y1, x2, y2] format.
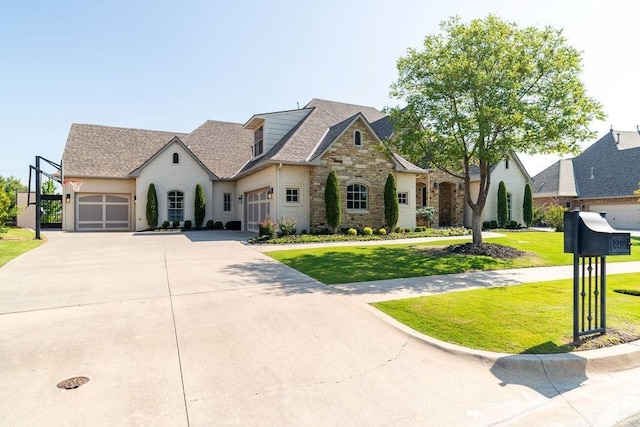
[464, 161, 528, 227]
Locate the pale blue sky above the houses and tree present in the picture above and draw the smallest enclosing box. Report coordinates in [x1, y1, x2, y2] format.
[0, 0, 640, 186]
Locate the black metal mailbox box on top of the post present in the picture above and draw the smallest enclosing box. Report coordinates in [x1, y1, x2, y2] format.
[564, 212, 631, 256]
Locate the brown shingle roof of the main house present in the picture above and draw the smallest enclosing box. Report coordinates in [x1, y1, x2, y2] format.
[62, 99, 419, 179]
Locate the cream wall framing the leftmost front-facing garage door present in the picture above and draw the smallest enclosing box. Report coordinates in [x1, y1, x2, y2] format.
[62, 176, 135, 231]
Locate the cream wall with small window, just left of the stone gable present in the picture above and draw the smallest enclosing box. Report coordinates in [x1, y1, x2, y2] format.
[272, 165, 311, 233]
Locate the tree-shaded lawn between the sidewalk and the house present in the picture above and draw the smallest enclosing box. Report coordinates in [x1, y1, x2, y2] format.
[267, 232, 640, 284]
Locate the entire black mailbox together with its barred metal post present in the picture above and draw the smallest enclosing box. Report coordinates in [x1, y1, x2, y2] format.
[564, 211, 631, 344]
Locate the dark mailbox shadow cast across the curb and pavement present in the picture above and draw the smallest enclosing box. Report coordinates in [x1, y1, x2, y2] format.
[491, 342, 588, 399]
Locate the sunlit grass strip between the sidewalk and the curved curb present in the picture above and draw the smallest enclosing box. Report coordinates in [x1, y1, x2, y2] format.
[373, 273, 640, 353]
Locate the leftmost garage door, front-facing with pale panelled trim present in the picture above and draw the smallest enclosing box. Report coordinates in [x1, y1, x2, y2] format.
[76, 194, 130, 231]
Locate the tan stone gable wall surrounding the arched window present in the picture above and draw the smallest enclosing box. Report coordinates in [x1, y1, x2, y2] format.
[309, 120, 394, 228]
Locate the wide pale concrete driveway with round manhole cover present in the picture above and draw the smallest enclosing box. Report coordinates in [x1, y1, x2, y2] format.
[0, 232, 640, 426]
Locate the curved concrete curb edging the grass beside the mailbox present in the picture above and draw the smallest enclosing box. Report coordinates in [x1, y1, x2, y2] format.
[363, 302, 640, 376]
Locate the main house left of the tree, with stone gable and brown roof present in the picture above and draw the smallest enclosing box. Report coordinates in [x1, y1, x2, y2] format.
[62, 99, 427, 231]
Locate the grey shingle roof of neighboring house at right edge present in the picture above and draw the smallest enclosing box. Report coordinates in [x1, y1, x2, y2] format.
[533, 129, 640, 199]
